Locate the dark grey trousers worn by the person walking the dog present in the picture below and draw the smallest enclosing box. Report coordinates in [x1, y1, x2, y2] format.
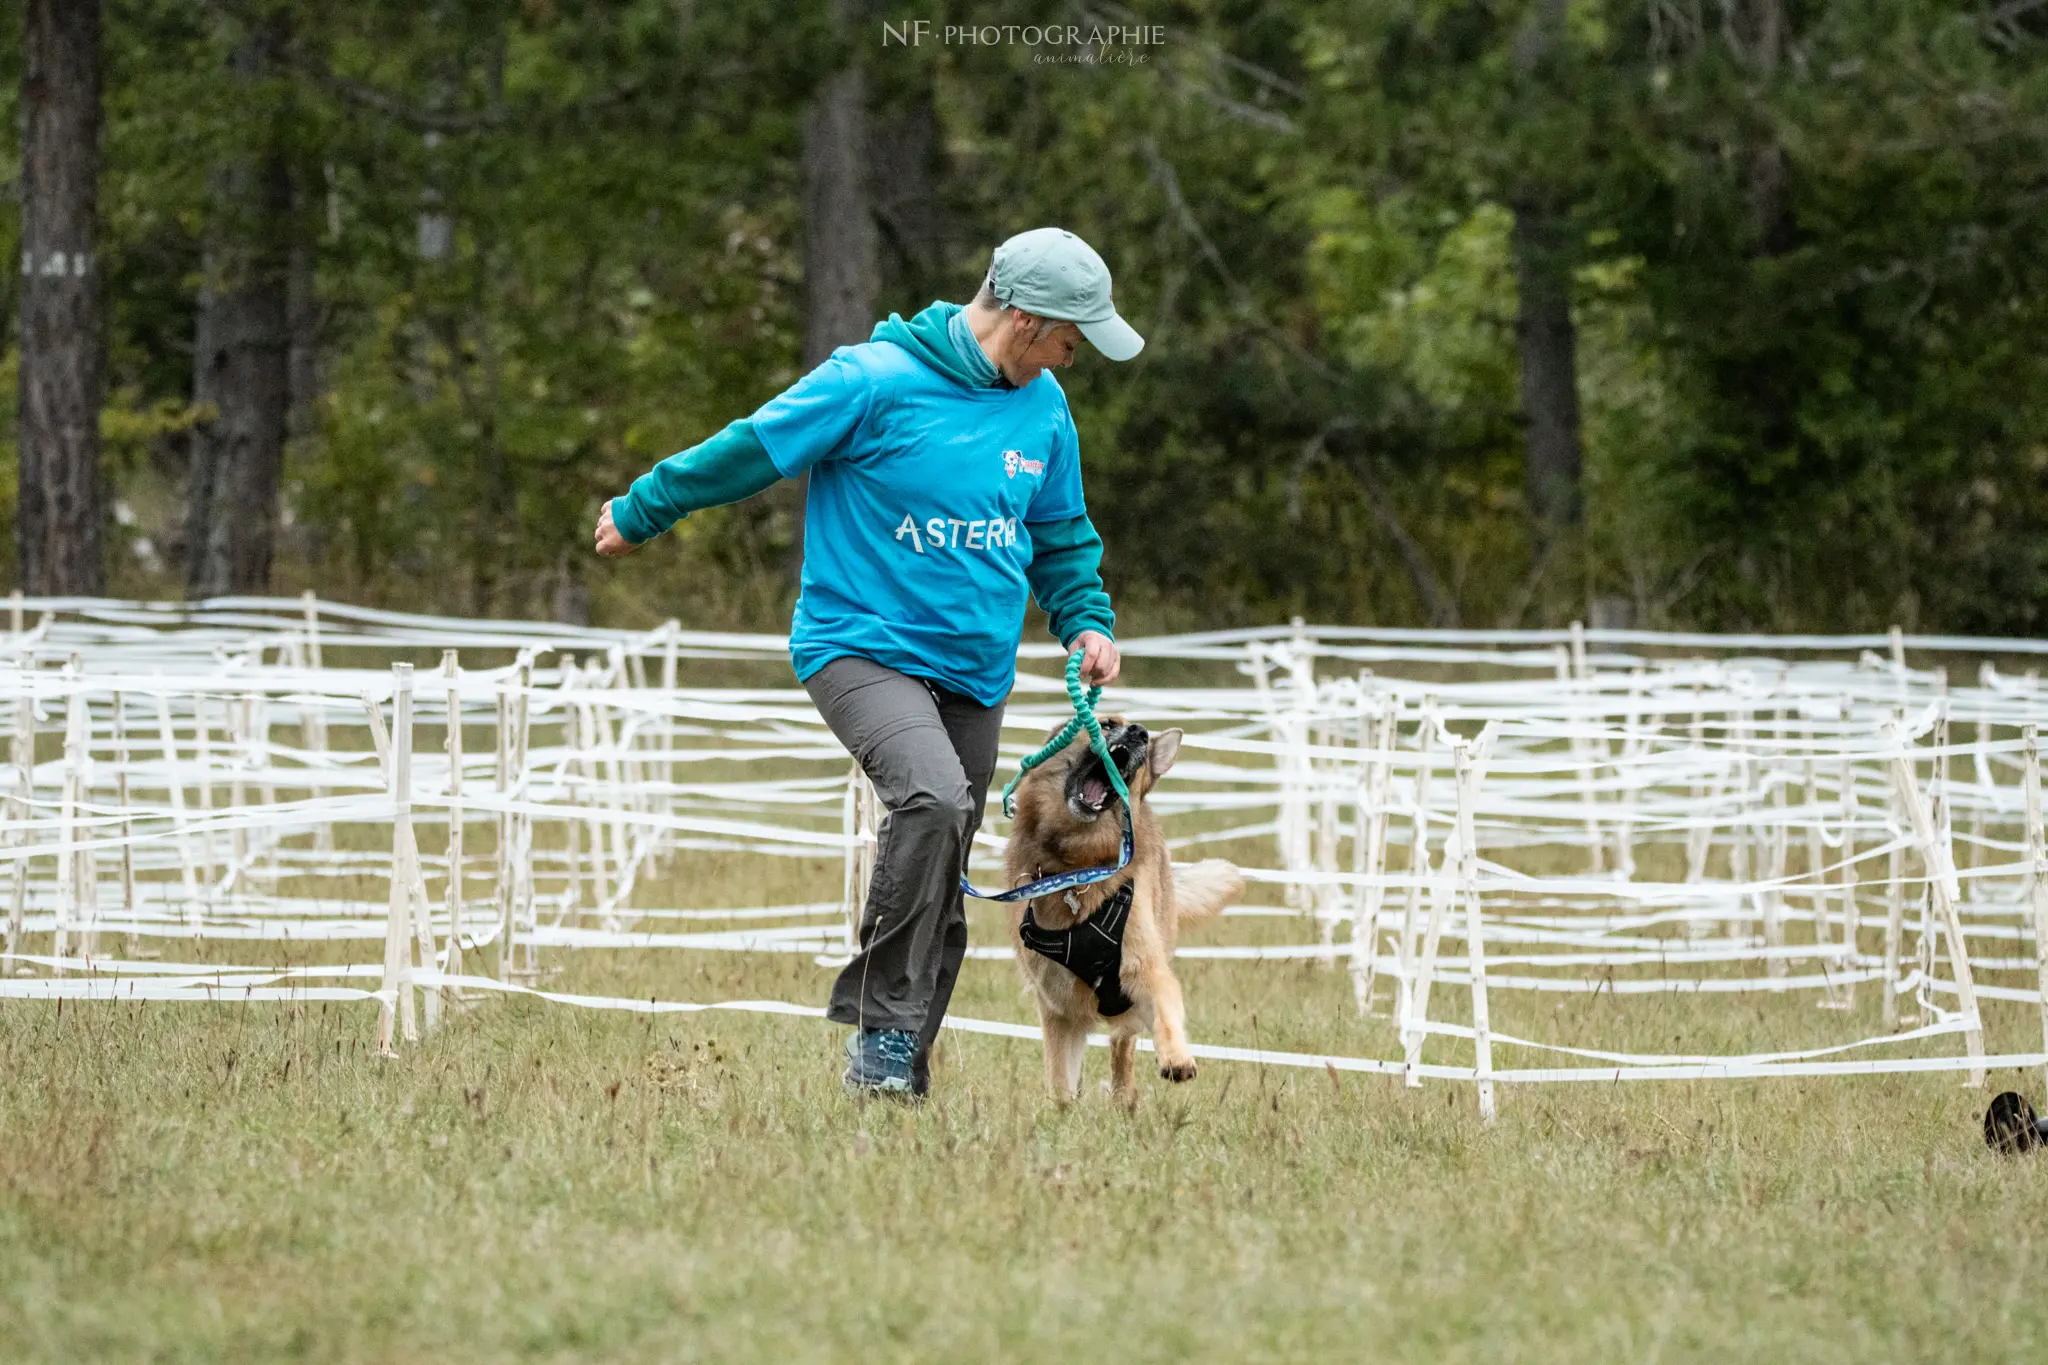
[805, 657, 1004, 1070]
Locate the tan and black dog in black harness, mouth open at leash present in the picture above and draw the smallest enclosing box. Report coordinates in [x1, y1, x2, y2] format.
[1006, 716, 1245, 1105]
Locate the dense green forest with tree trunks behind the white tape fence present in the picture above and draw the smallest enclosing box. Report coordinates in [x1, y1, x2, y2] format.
[0, 0, 2048, 634]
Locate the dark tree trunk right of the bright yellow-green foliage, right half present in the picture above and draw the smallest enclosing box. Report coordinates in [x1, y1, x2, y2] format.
[1513, 201, 1579, 544]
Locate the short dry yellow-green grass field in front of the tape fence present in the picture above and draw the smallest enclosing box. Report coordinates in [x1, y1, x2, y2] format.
[0, 834, 2048, 1365]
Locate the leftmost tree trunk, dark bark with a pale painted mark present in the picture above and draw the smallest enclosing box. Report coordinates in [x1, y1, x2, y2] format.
[14, 0, 106, 593]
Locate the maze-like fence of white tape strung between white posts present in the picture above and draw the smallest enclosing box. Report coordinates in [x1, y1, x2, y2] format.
[0, 596, 2048, 1115]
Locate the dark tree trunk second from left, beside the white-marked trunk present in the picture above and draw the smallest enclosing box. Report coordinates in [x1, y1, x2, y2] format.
[184, 29, 291, 598]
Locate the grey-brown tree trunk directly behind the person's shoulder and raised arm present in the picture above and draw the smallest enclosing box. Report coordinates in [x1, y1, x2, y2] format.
[791, 9, 881, 577]
